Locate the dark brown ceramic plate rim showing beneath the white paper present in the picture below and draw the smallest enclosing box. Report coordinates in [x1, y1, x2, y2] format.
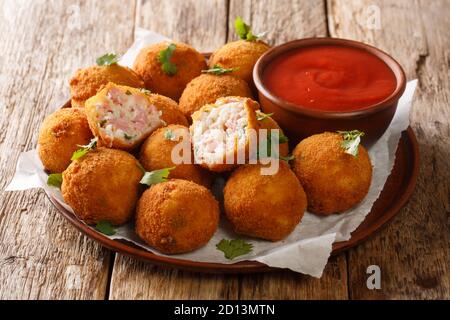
[47, 102, 419, 273]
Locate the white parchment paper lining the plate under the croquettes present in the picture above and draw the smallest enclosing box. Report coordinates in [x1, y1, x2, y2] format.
[6, 29, 417, 277]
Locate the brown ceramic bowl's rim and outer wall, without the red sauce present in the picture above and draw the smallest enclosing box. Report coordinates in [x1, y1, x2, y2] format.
[253, 38, 406, 145]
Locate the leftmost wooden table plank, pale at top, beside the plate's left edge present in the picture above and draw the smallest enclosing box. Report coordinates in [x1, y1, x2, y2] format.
[0, 0, 135, 299]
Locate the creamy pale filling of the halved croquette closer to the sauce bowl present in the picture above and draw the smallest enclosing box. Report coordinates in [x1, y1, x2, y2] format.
[192, 101, 248, 164]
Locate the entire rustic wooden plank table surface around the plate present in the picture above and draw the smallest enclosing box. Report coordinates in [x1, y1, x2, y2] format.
[0, 0, 450, 299]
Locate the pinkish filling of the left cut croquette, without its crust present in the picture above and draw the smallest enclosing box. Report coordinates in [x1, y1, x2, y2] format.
[96, 88, 162, 144]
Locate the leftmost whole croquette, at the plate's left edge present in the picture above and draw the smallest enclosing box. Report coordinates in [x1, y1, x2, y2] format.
[38, 108, 93, 173]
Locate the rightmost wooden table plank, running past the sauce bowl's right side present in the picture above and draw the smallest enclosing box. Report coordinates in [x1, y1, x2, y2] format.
[328, 0, 450, 299]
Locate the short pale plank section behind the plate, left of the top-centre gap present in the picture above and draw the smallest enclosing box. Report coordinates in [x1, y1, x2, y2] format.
[136, 0, 228, 52]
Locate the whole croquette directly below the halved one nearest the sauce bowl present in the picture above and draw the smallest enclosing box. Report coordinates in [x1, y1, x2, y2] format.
[224, 161, 307, 241]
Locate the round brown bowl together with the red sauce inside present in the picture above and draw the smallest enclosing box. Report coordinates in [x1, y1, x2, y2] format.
[253, 38, 406, 145]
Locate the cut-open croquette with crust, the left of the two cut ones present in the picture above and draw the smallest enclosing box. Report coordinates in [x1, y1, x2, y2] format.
[85, 83, 187, 150]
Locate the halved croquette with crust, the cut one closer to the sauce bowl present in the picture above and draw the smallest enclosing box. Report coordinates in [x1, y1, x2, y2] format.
[190, 97, 259, 172]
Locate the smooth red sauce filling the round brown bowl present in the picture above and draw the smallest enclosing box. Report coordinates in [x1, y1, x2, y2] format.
[263, 45, 397, 111]
